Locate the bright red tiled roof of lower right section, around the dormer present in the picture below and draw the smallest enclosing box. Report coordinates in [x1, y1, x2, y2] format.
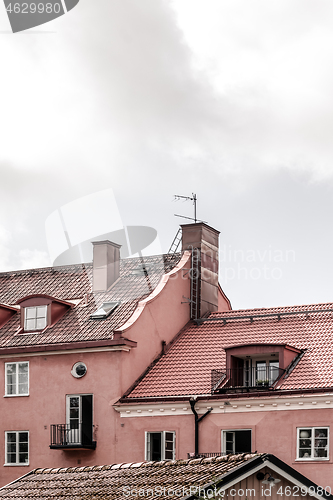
[127, 304, 333, 398]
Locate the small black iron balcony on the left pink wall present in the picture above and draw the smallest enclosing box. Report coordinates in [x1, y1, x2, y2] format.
[50, 423, 96, 450]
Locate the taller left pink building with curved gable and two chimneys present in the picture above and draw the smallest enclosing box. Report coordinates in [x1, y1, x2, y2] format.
[0, 224, 230, 485]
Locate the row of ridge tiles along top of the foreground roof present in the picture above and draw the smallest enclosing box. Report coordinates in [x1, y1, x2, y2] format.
[31, 453, 264, 474]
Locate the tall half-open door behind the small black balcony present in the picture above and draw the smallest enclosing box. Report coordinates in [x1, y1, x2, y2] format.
[66, 394, 93, 445]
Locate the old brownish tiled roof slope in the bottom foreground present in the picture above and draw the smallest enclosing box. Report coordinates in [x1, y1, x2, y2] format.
[0, 454, 264, 500]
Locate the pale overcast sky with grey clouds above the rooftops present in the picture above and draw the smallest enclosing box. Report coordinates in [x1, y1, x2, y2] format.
[0, 0, 333, 309]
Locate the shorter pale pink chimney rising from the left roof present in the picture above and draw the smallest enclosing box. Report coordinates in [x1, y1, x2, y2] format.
[93, 240, 121, 292]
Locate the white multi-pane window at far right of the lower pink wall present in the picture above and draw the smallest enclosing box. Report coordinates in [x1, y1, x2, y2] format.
[297, 427, 329, 460]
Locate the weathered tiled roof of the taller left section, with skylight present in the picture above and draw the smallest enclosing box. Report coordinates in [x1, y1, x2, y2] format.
[0, 254, 180, 351]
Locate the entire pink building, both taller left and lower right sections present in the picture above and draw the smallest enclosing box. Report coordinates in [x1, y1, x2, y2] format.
[0, 223, 333, 489]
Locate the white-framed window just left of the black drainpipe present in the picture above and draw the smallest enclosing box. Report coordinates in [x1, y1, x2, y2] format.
[146, 431, 176, 462]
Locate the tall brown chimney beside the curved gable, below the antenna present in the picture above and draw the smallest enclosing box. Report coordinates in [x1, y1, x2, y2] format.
[181, 222, 220, 319]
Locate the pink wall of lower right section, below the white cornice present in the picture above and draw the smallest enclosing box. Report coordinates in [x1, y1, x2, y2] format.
[114, 401, 333, 491]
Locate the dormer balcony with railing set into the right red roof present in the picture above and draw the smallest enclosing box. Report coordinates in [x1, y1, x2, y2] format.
[211, 365, 286, 394]
